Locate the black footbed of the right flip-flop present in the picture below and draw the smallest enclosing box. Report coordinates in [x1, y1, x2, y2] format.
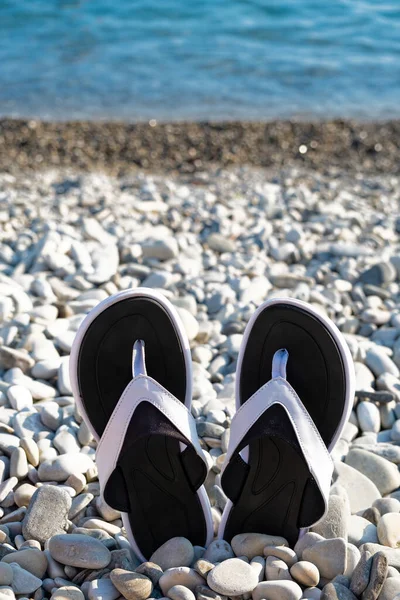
[222, 302, 346, 544]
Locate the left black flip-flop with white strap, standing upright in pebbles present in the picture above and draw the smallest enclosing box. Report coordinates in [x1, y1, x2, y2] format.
[70, 288, 213, 560]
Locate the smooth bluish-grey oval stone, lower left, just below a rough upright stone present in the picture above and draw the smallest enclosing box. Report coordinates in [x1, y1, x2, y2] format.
[49, 534, 111, 569]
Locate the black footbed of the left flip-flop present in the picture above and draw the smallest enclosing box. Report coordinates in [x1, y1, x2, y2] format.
[78, 296, 206, 557]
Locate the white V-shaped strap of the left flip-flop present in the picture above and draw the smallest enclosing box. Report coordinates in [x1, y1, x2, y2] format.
[96, 376, 207, 493]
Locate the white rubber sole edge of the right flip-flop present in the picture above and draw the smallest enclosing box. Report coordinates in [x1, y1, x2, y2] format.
[218, 298, 356, 539]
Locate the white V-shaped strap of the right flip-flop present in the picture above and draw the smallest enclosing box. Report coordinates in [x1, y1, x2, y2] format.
[224, 376, 333, 507]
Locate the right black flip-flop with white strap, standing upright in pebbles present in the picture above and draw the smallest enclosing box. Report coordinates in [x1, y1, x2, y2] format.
[219, 298, 354, 544]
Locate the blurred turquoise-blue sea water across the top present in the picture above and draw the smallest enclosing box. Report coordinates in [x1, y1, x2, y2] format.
[0, 0, 400, 121]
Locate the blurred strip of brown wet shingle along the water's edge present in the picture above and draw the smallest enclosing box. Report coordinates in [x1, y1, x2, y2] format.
[0, 118, 400, 175]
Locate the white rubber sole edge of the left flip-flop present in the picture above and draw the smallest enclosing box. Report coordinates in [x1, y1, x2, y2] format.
[69, 287, 214, 561]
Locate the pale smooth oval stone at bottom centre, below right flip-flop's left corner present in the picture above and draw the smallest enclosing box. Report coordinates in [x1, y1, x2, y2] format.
[207, 558, 258, 598]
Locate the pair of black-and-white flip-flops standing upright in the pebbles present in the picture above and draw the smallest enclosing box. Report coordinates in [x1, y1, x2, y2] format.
[70, 288, 354, 560]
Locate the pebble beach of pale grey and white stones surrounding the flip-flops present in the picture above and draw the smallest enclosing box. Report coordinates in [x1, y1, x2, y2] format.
[0, 136, 400, 600]
